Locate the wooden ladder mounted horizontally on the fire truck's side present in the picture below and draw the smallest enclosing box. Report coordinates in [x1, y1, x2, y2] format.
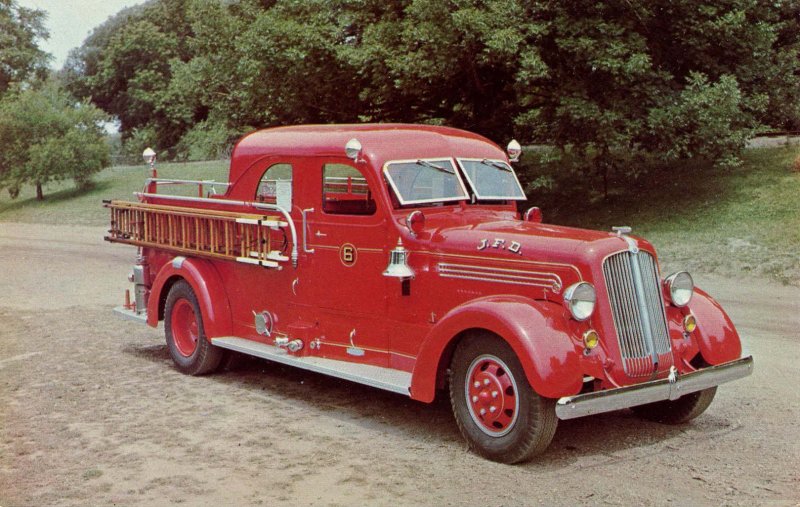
[103, 201, 294, 269]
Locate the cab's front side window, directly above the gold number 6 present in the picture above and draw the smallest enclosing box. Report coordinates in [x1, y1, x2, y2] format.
[322, 164, 376, 215]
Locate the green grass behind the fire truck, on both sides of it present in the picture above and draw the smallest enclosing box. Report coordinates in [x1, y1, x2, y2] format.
[0, 147, 800, 285]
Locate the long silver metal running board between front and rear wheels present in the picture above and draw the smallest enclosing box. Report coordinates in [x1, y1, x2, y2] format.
[211, 336, 411, 396]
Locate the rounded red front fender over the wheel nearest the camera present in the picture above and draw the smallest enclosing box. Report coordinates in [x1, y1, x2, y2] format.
[411, 296, 583, 402]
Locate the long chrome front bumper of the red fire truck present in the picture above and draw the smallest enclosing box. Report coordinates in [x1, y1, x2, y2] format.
[556, 356, 753, 419]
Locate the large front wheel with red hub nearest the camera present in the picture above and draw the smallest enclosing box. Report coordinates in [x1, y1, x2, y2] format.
[450, 333, 558, 463]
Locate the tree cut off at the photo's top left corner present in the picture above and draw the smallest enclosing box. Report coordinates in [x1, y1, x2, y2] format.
[0, 0, 49, 97]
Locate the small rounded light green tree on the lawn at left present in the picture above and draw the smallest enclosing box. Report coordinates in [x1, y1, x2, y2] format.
[0, 80, 110, 200]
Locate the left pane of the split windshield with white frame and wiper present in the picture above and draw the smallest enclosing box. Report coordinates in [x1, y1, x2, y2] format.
[384, 158, 469, 204]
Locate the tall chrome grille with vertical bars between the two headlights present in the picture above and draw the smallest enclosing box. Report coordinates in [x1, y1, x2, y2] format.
[603, 251, 672, 377]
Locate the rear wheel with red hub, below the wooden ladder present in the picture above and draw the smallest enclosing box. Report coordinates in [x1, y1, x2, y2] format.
[164, 280, 223, 375]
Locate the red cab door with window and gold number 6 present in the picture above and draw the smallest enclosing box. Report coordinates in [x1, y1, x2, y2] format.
[297, 158, 389, 366]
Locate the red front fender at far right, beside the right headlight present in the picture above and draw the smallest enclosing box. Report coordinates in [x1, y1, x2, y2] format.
[689, 288, 742, 364]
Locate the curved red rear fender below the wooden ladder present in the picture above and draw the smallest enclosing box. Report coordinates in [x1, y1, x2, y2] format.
[147, 257, 233, 338]
